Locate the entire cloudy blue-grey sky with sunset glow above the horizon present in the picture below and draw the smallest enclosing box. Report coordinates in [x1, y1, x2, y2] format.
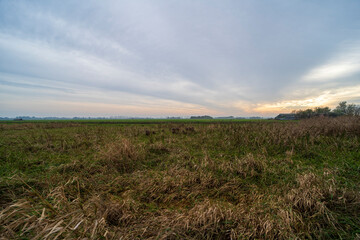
[0, 0, 360, 117]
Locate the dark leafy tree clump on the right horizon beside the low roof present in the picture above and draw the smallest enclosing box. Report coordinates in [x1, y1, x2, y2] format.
[293, 101, 360, 119]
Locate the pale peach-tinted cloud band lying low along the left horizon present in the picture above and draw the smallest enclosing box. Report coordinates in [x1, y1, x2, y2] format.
[0, 86, 219, 117]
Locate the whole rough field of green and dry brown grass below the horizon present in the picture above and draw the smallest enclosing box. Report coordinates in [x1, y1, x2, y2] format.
[0, 117, 360, 239]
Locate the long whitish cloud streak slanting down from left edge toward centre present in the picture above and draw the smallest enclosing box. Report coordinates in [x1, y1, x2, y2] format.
[0, 34, 207, 99]
